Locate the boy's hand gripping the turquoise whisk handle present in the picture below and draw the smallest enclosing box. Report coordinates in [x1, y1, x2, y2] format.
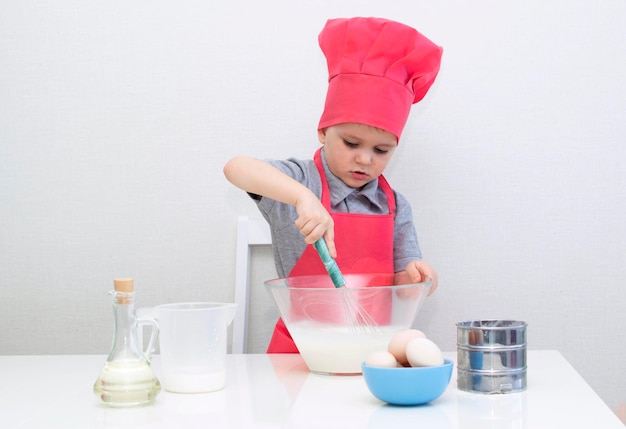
[295, 193, 337, 258]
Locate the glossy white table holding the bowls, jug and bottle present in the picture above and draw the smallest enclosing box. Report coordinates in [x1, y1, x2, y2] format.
[0, 351, 624, 429]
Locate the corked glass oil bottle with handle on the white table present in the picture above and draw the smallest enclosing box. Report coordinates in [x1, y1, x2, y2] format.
[93, 278, 161, 407]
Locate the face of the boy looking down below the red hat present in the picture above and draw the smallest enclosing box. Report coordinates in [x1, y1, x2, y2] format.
[318, 123, 397, 189]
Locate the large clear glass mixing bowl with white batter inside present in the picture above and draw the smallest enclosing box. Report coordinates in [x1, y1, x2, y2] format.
[265, 274, 432, 375]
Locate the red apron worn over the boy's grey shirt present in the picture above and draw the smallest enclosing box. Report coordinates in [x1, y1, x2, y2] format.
[267, 148, 396, 353]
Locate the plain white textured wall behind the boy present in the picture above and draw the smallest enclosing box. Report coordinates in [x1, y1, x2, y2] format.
[0, 0, 626, 407]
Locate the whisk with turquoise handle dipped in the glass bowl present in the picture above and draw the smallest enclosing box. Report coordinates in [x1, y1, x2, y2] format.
[313, 238, 378, 333]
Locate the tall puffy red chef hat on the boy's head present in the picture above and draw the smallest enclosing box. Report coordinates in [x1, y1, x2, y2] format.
[318, 18, 443, 139]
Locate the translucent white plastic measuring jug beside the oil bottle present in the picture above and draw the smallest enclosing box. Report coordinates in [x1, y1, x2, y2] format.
[146, 302, 237, 393]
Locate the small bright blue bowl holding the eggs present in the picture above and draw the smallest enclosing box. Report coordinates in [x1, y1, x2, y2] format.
[361, 359, 452, 405]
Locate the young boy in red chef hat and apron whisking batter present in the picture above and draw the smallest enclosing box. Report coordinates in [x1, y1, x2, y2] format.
[224, 18, 442, 353]
